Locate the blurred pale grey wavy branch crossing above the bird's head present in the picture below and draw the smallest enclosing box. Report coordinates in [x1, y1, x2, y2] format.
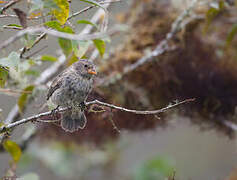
[0, 27, 118, 50]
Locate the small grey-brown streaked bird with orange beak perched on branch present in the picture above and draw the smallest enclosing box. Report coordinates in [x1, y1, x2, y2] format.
[47, 59, 96, 132]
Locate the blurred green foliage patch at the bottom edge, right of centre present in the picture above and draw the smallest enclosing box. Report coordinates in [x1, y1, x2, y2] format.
[133, 155, 175, 180]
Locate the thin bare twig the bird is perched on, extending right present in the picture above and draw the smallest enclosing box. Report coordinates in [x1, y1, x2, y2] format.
[0, 99, 195, 133]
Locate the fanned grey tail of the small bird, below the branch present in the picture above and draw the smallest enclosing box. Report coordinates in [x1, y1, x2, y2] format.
[61, 110, 87, 132]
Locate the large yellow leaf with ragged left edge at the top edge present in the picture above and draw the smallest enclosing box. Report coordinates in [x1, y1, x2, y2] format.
[52, 0, 69, 25]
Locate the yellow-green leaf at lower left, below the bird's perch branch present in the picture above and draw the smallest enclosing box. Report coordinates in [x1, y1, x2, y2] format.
[3, 140, 21, 163]
